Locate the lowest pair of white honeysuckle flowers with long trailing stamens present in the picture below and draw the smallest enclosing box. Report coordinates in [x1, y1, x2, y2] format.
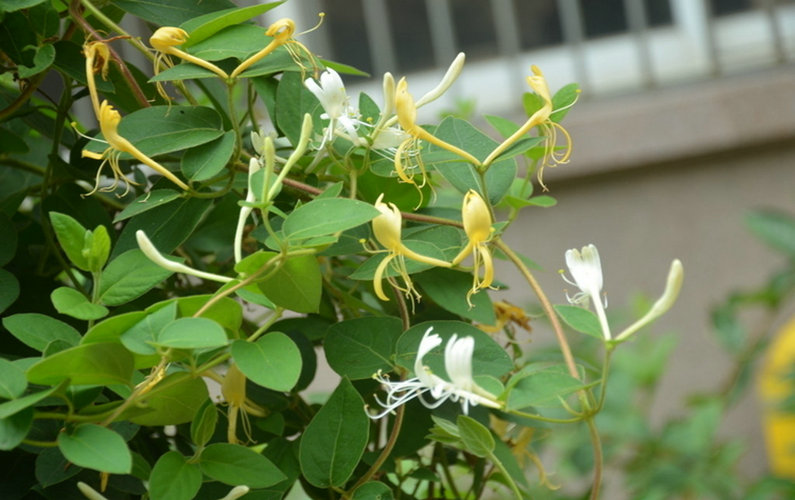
[370, 327, 502, 419]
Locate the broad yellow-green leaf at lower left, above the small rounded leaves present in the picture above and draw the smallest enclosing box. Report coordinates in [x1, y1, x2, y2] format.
[26, 342, 133, 385]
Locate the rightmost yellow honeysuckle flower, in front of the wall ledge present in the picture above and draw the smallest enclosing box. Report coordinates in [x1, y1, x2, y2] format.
[483, 65, 572, 190]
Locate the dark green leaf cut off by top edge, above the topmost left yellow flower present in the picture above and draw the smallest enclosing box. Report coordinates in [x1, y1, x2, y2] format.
[114, 0, 235, 26]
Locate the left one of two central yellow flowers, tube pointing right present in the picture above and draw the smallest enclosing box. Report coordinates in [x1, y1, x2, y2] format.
[372, 194, 450, 301]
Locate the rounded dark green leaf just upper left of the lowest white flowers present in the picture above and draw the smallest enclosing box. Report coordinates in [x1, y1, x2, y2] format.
[323, 316, 403, 380]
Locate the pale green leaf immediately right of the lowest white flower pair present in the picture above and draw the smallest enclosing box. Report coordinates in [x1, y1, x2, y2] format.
[507, 364, 584, 410]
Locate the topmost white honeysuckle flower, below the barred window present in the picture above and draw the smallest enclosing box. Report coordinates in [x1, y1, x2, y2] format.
[304, 68, 361, 147]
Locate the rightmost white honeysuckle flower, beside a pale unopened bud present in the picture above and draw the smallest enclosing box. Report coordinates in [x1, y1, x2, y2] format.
[563, 244, 612, 340]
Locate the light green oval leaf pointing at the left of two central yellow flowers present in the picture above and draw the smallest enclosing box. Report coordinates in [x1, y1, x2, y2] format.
[282, 198, 381, 241]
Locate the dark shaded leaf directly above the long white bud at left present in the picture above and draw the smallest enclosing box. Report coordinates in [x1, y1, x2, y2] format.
[111, 198, 212, 258]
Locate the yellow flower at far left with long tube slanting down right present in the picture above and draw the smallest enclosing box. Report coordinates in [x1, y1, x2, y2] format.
[83, 101, 190, 196]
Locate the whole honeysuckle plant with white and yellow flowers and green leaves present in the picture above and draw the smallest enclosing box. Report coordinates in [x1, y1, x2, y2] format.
[0, 0, 683, 499]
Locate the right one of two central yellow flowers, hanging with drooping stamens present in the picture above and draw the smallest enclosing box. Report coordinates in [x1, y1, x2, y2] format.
[452, 189, 494, 307]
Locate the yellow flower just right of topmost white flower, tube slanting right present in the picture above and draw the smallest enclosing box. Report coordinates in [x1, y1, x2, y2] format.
[395, 77, 480, 188]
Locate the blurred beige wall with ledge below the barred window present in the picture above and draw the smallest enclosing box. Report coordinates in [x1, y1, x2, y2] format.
[498, 67, 795, 473]
